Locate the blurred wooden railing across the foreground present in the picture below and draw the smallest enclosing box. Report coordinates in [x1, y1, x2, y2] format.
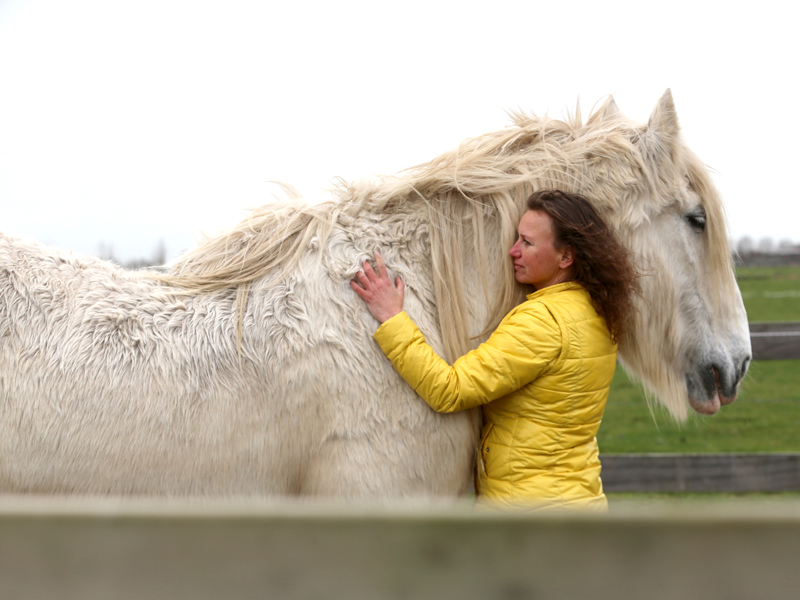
[0, 497, 800, 600]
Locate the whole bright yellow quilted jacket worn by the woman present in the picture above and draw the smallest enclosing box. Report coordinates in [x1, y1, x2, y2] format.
[375, 282, 617, 510]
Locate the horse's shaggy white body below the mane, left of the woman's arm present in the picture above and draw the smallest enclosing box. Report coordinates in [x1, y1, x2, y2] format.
[0, 234, 474, 497]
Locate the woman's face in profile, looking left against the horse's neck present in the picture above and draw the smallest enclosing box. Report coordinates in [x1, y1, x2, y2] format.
[508, 210, 574, 290]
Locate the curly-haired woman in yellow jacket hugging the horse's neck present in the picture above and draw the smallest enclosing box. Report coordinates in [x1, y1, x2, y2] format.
[351, 190, 636, 510]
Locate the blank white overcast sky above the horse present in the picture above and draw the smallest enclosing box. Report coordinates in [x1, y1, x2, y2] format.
[0, 0, 800, 260]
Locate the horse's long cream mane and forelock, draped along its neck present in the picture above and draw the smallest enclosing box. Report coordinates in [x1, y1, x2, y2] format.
[160, 98, 735, 360]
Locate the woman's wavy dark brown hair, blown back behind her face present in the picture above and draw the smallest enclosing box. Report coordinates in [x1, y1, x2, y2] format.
[527, 190, 639, 342]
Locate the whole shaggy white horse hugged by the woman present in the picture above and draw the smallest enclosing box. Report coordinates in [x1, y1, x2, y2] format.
[0, 91, 750, 498]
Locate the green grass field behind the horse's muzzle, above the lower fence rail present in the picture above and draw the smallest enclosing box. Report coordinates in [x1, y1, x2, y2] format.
[598, 267, 800, 454]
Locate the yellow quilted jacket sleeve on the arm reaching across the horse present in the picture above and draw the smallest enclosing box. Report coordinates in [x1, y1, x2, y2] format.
[375, 303, 562, 412]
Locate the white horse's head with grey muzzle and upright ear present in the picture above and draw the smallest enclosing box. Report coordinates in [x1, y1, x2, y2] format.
[607, 91, 751, 419]
